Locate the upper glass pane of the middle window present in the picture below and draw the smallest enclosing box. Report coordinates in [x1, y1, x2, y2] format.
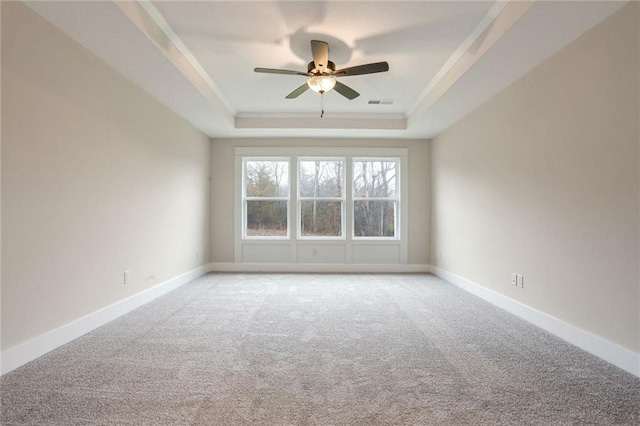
[298, 160, 342, 198]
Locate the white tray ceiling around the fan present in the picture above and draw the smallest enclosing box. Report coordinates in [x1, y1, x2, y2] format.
[27, 1, 624, 138]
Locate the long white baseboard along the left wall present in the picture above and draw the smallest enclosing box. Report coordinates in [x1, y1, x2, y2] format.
[0, 263, 211, 374]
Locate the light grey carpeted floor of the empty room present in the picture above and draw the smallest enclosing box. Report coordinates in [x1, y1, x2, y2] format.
[0, 274, 640, 425]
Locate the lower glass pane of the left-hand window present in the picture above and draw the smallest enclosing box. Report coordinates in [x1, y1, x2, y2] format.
[247, 200, 289, 237]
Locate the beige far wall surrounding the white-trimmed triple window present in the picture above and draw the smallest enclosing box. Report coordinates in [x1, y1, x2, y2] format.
[211, 138, 430, 264]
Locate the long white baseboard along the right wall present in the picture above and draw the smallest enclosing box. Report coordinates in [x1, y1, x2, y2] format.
[431, 266, 640, 377]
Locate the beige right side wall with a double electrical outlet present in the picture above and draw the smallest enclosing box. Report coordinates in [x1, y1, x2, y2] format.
[432, 3, 640, 352]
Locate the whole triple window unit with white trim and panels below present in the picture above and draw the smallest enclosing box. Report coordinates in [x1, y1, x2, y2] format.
[234, 146, 408, 251]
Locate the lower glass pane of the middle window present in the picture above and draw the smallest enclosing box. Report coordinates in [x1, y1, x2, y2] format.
[300, 200, 342, 237]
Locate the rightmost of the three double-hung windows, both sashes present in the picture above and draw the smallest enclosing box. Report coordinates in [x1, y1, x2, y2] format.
[353, 158, 399, 238]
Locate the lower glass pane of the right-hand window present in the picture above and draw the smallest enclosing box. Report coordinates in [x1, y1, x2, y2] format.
[353, 200, 396, 237]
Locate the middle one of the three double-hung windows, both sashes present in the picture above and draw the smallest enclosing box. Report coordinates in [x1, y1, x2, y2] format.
[298, 158, 345, 238]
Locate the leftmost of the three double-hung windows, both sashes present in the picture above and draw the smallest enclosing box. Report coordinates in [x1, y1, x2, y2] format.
[243, 158, 289, 238]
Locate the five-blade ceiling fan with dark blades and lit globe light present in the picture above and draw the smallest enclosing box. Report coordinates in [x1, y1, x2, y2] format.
[254, 40, 389, 100]
